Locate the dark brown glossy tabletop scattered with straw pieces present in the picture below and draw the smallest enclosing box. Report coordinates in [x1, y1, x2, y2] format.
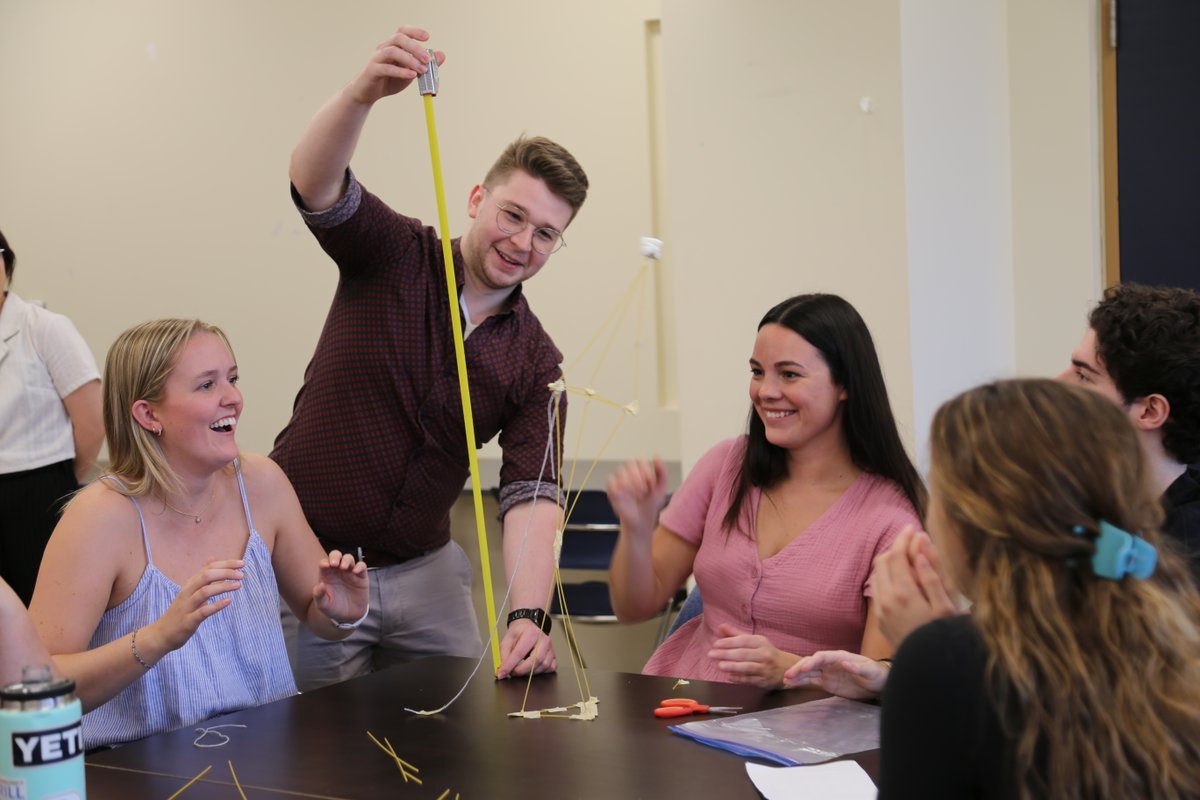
[86, 657, 878, 800]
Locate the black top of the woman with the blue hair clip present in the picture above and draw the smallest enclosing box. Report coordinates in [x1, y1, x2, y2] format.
[880, 615, 1018, 800]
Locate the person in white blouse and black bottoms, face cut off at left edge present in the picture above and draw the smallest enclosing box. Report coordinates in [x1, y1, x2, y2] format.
[0, 227, 104, 604]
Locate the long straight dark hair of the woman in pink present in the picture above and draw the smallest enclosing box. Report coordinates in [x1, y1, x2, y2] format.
[722, 294, 925, 530]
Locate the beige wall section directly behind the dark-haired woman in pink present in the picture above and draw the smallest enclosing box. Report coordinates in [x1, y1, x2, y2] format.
[662, 0, 912, 465]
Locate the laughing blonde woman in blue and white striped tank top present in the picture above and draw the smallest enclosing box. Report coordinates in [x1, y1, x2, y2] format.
[30, 319, 368, 747]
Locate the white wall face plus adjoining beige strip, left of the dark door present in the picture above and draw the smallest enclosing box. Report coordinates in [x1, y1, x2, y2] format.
[901, 0, 1100, 470]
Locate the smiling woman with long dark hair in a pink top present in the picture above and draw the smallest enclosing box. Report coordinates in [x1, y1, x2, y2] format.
[608, 294, 925, 688]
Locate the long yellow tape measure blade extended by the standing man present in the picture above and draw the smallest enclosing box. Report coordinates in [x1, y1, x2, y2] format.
[424, 95, 500, 672]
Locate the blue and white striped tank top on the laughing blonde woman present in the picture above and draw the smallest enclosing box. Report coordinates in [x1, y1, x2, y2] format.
[83, 462, 296, 747]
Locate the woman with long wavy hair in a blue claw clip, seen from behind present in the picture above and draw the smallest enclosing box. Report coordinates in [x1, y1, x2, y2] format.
[880, 380, 1200, 800]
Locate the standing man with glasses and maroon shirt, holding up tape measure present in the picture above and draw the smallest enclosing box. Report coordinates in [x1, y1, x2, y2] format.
[271, 26, 588, 690]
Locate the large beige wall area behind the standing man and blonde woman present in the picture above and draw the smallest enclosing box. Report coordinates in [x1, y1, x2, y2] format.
[0, 0, 678, 474]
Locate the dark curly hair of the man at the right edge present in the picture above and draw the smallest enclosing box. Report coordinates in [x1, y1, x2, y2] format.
[1088, 283, 1200, 464]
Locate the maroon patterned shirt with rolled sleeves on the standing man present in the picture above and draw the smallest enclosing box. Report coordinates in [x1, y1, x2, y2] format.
[271, 175, 566, 558]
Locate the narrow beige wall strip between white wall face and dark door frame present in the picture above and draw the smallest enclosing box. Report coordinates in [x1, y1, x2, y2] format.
[1008, 0, 1104, 375]
